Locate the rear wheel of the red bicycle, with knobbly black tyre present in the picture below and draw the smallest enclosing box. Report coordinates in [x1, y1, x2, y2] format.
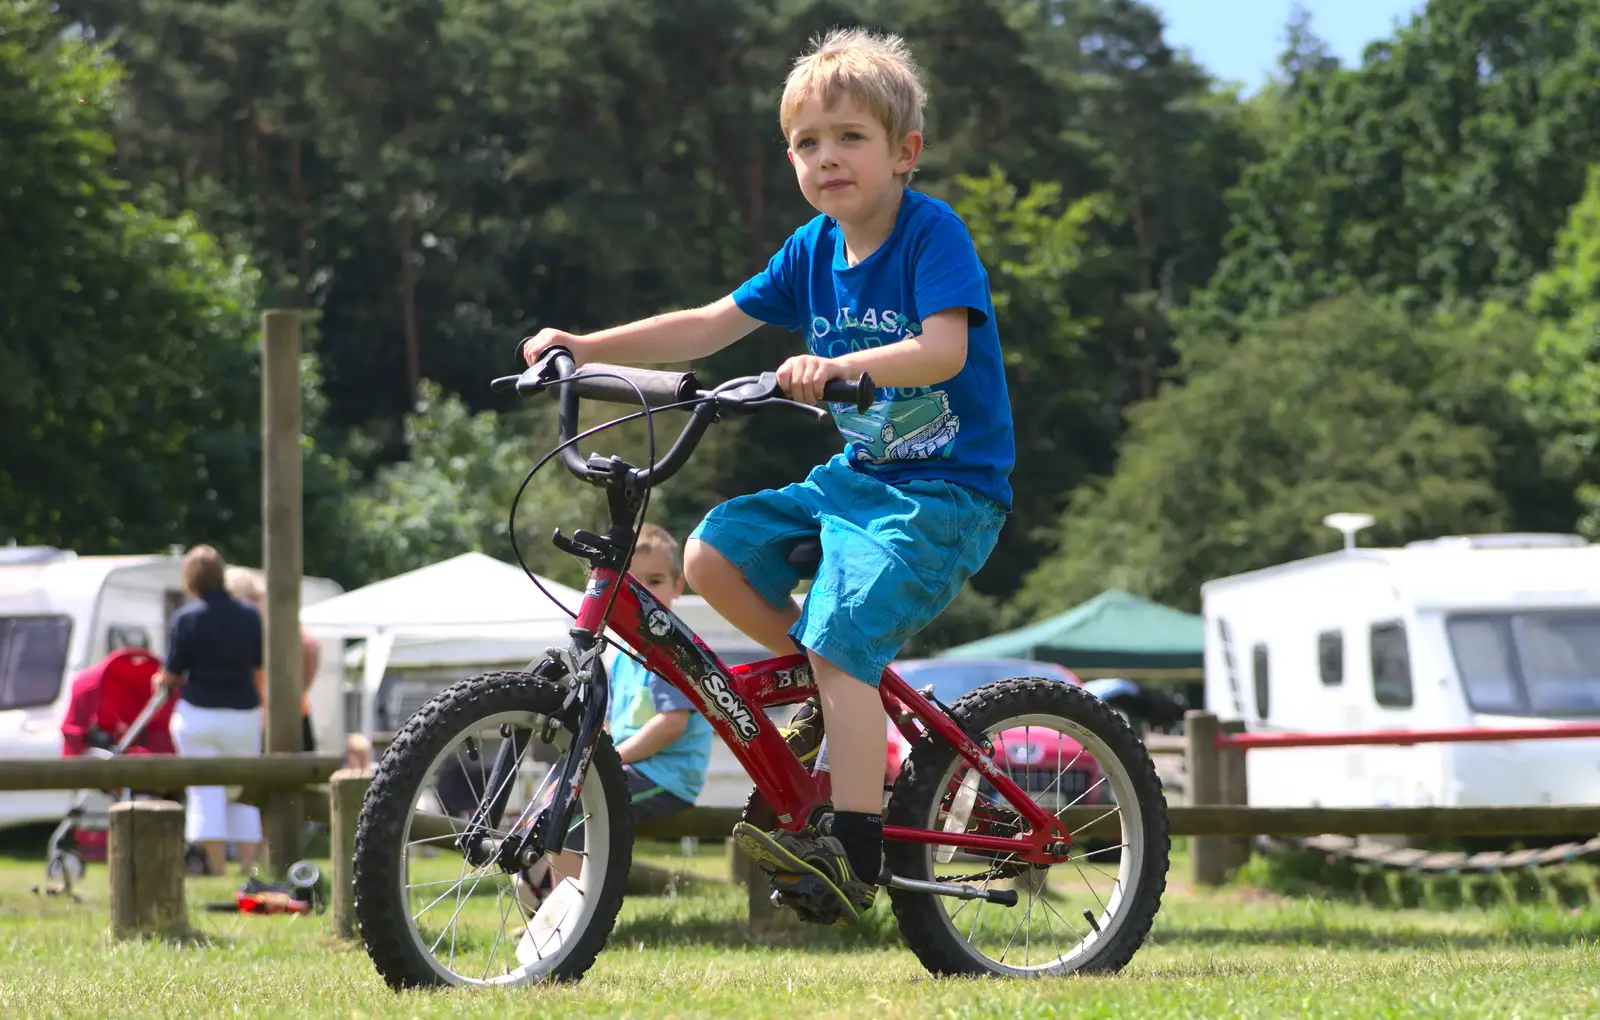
[885, 678, 1170, 977]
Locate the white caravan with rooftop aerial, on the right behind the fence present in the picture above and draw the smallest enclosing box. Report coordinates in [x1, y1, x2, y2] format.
[1200, 530, 1600, 807]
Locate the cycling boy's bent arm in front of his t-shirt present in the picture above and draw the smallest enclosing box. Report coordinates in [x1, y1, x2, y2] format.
[778, 307, 968, 403]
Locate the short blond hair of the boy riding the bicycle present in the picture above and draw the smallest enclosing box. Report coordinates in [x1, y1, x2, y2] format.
[778, 29, 928, 145]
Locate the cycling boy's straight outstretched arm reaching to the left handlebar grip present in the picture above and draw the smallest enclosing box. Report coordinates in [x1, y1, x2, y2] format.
[522, 294, 762, 365]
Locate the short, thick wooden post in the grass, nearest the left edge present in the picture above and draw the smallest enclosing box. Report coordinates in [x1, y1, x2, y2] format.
[106, 801, 189, 938]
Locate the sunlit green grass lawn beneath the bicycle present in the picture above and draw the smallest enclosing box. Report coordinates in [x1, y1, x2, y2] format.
[0, 846, 1600, 1020]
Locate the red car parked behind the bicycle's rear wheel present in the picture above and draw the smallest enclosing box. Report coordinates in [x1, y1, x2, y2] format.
[886, 659, 1112, 811]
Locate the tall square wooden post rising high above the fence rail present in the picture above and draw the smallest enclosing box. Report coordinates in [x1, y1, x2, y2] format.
[261, 310, 306, 878]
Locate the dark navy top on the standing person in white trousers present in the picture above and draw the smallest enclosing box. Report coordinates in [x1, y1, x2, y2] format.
[165, 588, 261, 708]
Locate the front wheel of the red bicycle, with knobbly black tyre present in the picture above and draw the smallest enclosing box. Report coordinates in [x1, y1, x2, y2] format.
[354, 673, 634, 990]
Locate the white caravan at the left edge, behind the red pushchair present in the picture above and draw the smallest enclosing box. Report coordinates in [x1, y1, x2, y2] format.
[0, 545, 344, 827]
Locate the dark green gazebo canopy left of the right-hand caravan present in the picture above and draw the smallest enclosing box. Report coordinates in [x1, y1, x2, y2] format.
[939, 590, 1205, 675]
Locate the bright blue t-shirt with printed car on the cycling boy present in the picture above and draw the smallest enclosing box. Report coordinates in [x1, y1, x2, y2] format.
[733, 189, 1016, 510]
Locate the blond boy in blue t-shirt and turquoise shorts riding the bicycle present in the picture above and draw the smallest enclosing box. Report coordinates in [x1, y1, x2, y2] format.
[523, 29, 1014, 916]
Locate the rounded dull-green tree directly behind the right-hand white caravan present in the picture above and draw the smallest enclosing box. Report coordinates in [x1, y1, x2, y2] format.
[1019, 296, 1531, 616]
